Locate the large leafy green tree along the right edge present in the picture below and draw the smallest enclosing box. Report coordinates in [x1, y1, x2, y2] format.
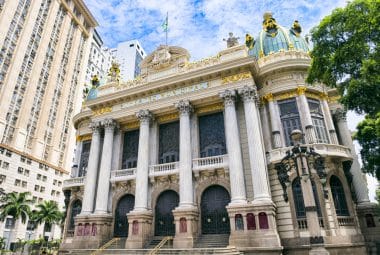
[307, 0, 380, 179]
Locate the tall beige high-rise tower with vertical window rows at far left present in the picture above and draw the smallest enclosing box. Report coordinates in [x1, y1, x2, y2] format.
[0, 0, 97, 247]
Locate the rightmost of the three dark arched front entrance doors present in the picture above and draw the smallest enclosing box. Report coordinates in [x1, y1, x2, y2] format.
[201, 185, 231, 234]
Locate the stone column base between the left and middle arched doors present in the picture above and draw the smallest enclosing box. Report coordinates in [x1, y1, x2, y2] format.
[125, 210, 153, 249]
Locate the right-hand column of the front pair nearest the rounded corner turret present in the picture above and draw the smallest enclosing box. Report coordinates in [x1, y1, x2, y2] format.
[239, 86, 273, 204]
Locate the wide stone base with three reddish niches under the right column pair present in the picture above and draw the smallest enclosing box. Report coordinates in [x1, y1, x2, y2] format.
[227, 203, 282, 250]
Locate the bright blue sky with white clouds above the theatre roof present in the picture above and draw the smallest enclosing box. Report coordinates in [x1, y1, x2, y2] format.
[85, 0, 346, 60]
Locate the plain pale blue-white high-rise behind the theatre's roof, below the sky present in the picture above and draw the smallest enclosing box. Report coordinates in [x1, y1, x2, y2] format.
[113, 40, 146, 81]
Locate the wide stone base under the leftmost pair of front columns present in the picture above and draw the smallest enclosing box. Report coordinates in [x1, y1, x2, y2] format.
[61, 214, 113, 249]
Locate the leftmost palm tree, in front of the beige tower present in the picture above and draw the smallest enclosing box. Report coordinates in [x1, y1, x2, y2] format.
[0, 192, 33, 249]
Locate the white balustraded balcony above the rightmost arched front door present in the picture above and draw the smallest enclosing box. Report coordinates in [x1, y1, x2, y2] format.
[193, 154, 228, 176]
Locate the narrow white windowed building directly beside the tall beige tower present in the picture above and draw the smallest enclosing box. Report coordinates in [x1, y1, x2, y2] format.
[85, 30, 115, 85]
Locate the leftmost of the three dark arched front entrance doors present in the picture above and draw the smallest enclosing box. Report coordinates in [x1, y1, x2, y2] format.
[114, 194, 135, 237]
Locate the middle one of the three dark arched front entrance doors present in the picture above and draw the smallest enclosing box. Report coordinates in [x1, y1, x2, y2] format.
[154, 190, 179, 236]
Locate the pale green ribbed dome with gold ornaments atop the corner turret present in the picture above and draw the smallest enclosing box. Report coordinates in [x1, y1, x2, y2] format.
[249, 13, 309, 58]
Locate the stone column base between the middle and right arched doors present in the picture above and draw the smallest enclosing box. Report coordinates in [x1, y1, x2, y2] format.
[173, 207, 199, 249]
